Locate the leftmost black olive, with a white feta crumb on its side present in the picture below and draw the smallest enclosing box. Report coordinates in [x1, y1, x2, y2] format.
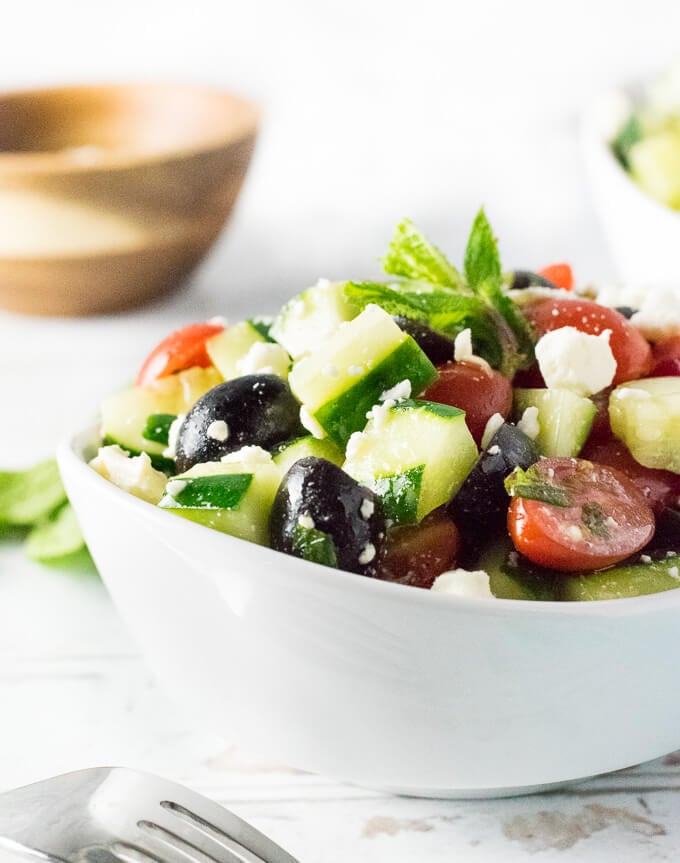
[175, 375, 302, 473]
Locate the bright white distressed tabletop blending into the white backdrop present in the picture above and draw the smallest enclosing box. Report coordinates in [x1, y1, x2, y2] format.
[0, 0, 680, 863]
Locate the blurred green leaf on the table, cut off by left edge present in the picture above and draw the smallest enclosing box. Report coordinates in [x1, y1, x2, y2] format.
[0, 459, 66, 525]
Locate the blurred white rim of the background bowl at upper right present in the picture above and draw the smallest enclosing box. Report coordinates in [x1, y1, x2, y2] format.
[580, 81, 680, 229]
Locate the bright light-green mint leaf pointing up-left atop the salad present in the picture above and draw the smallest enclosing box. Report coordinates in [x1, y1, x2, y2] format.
[382, 219, 462, 289]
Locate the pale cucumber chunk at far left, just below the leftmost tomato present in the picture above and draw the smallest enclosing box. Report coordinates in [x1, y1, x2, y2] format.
[101, 367, 222, 469]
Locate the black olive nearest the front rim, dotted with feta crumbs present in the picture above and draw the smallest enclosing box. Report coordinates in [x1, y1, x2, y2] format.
[269, 456, 385, 574]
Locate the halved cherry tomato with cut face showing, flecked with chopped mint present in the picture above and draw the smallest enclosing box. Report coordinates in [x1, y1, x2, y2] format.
[508, 458, 654, 572]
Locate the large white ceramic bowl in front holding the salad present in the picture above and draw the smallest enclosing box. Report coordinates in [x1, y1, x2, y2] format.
[59, 430, 680, 797]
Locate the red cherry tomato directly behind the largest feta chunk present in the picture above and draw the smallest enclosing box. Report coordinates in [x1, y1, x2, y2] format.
[522, 297, 652, 384]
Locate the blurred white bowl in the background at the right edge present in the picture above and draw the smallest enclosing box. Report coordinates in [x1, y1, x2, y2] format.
[581, 90, 680, 296]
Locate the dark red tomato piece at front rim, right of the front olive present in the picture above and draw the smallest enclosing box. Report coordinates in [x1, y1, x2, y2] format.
[376, 510, 460, 590]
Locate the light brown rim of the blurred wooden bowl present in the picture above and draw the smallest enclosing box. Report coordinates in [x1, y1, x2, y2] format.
[0, 79, 261, 176]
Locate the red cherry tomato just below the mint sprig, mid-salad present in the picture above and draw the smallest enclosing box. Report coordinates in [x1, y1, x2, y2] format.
[423, 361, 512, 446]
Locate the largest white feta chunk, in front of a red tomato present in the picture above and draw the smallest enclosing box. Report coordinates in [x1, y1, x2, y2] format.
[536, 327, 616, 396]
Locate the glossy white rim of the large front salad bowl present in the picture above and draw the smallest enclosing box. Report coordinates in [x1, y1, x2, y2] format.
[56, 422, 680, 619]
